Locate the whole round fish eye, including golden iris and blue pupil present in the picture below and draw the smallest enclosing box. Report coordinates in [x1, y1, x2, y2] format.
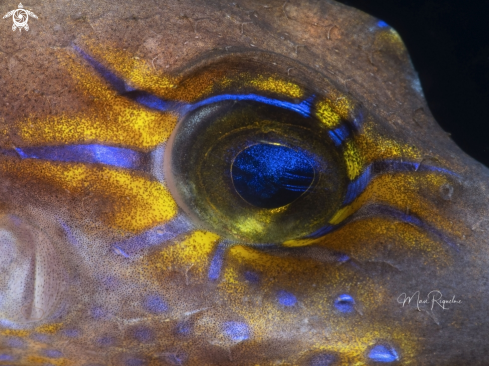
[165, 91, 347, 244]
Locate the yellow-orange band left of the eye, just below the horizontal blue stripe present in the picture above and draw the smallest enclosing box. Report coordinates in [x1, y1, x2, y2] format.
[0, 159, 177, 232]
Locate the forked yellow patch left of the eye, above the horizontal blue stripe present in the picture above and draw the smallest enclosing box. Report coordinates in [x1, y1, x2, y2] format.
[11, 50, 178, 151]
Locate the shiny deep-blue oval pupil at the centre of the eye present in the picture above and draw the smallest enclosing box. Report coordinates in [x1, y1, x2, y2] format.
[231, 144, 314, 208]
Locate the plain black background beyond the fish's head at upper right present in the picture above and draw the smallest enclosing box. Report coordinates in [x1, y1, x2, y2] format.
[338, 0, 489, 167]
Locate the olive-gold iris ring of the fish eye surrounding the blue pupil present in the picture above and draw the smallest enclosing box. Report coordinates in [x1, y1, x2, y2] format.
[164, 101, 347, 244]
